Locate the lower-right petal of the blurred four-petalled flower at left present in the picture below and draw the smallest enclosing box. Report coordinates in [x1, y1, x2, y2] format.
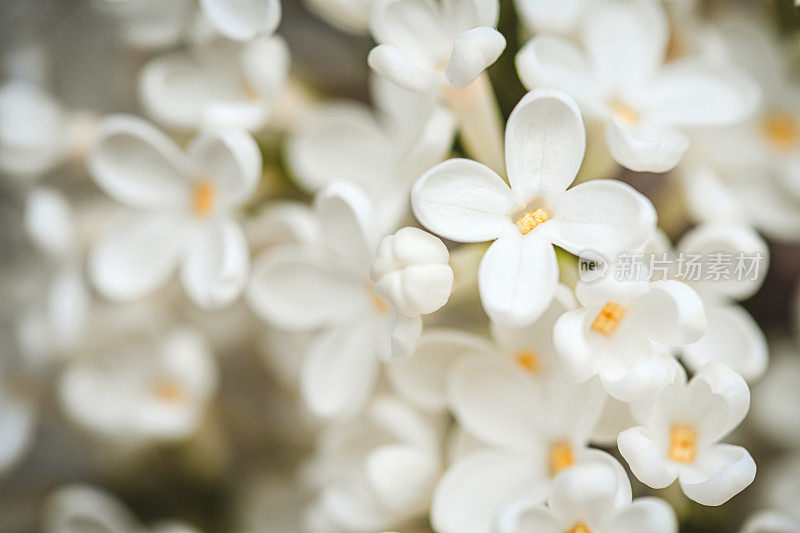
[181, 218, 250, 309]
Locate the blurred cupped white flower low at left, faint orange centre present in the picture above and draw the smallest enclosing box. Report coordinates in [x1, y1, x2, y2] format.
[58, 329, 217, 447]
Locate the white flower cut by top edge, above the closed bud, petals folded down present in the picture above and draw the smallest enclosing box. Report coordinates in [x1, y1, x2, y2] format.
[368, 0, 506, 92]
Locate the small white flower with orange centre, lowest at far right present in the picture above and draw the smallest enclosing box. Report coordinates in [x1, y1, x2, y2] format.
[617, 363, 756, 505]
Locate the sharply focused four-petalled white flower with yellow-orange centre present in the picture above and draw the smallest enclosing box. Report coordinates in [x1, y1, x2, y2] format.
[411, 89, 656, 326]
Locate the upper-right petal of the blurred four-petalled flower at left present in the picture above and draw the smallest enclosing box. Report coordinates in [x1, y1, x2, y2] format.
[188, 129, 261, 208]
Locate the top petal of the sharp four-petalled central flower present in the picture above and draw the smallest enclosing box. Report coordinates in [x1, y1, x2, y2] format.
[506, 88, 586, 205]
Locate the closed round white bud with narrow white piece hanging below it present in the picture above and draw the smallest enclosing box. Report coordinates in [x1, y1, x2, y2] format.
[370, 227, 453, 360]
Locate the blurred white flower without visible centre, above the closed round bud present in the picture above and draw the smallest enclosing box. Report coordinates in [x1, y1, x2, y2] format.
[286, 76, 455, 230]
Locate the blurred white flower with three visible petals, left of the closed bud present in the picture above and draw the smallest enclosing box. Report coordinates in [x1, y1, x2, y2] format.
[247, 183, 394, 417]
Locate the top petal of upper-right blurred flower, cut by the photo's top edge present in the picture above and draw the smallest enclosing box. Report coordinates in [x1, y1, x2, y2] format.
[583, 0, 668, 94]
